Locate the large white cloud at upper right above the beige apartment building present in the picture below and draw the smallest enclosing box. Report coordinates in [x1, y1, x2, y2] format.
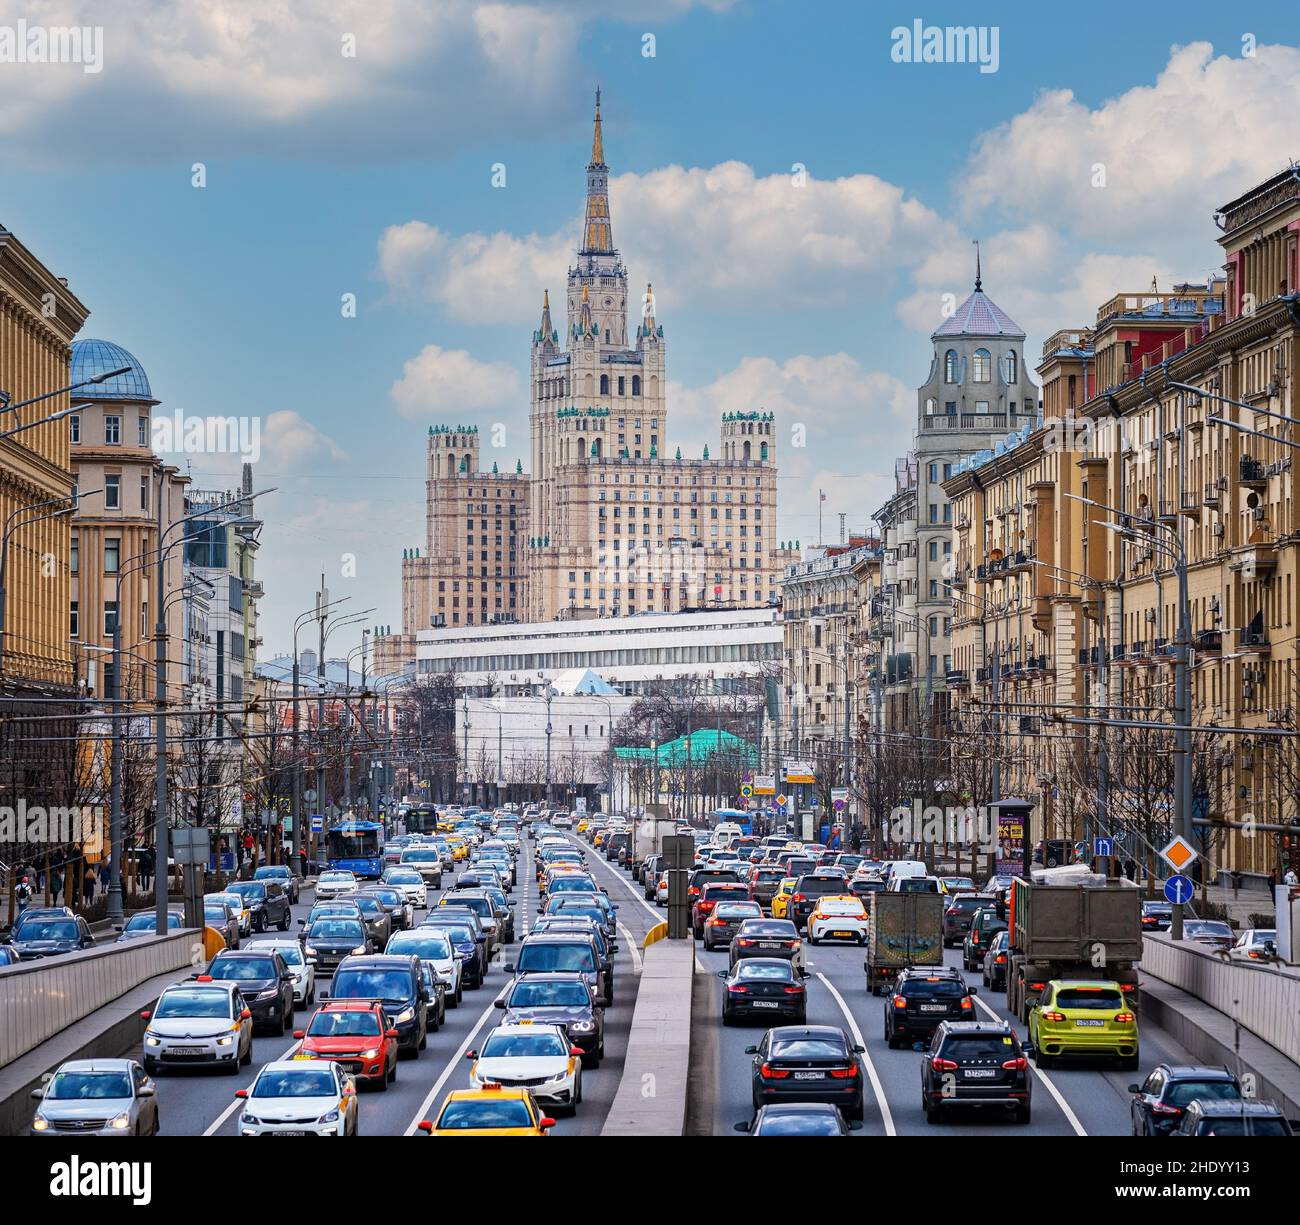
[959, 43, 1300, 246]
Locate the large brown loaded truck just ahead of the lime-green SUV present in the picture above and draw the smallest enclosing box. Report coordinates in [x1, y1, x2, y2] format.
[1006, 865, 1141, 1023]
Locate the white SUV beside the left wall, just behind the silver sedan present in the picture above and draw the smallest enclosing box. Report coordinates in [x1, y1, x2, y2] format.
[140, 978, 252, 1077]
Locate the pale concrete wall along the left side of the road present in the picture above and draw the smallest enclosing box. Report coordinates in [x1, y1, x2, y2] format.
[0, 931, 204, 1068]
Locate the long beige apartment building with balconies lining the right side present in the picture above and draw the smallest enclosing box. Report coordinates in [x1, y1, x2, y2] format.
[945, 172, 1300, 875]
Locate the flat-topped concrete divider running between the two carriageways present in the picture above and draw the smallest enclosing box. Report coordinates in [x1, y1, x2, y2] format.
[601, 940, 696, 1135]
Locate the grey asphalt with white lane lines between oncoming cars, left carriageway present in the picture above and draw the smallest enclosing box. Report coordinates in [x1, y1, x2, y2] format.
[106, 841, 654, 1135]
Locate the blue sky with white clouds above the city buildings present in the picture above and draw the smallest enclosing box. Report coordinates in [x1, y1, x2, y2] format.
[0, 0, 1300, 655]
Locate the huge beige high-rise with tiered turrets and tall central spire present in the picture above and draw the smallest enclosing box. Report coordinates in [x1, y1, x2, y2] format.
[377, 91, 794, 671]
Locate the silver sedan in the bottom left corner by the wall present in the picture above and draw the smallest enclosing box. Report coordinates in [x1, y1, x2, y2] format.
[27, 1059, 159, 1139]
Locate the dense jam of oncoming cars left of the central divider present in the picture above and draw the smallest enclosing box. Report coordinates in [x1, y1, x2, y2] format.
[30, 806, 654, 1137]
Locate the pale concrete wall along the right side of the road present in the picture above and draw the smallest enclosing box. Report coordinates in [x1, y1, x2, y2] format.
[1141, 934, 1300, 1064]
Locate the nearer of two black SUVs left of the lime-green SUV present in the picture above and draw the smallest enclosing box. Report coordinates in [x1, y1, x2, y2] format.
[920, 1021, 1032, 1124]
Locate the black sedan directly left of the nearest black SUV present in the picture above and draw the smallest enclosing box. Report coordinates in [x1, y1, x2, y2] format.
[745, 1025, 865, 1122]
